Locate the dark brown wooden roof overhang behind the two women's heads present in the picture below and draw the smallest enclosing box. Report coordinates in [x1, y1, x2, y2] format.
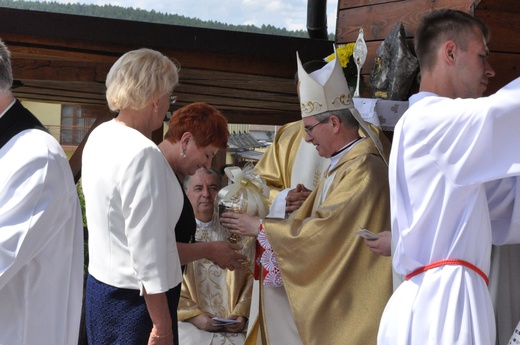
[0, 8, 333, 181]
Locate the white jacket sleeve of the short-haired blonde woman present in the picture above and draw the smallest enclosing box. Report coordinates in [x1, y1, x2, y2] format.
[121, 147, 175, 294]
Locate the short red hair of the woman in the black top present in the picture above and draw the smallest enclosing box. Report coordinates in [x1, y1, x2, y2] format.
[164, 102, 229, 149]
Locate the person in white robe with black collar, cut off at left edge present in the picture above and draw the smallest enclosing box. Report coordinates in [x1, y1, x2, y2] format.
[0, 41, 83, 345]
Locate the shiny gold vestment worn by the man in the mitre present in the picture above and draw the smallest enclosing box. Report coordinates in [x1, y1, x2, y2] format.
[264, 140, 392, 345]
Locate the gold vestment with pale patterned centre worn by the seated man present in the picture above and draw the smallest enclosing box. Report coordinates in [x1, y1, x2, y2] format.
[177, 221, 254, 344]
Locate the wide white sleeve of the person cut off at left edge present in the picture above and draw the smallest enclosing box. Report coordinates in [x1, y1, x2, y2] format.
[0, 129, 78, 289]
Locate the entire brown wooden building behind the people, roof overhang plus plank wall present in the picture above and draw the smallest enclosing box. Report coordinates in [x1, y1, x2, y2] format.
[0, 0, 520, 179]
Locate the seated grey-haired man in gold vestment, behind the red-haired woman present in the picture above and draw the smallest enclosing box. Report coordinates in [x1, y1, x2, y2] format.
[178, 168, 253, 345]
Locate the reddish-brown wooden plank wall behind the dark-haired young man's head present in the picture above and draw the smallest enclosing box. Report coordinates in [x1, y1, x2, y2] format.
[336, 0, 520, 96]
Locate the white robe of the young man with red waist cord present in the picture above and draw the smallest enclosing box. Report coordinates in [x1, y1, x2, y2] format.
[378, 79, 520, 345]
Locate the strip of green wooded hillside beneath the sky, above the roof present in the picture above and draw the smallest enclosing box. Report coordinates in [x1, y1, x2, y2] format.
[0, 0, 334, 40]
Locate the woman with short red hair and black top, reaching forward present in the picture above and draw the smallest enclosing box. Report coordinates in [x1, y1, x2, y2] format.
[159, 103, 246, 338]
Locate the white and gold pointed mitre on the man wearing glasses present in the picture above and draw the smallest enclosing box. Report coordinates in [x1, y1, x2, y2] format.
[296, 49, 354, 118]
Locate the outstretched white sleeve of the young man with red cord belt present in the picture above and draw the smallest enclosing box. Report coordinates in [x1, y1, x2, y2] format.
[430, 78, 520, 185]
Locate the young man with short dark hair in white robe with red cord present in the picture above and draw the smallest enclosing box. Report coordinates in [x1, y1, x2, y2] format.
[378, 10, 520, 345]
